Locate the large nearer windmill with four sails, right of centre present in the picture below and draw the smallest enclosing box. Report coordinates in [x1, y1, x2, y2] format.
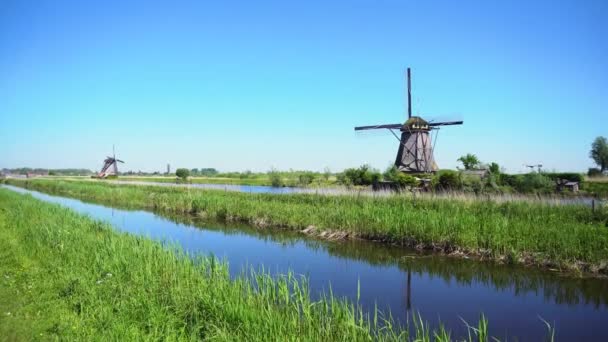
[355, 68, 462, 173]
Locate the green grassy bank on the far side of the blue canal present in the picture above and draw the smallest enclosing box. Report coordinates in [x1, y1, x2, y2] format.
[8, 180, 608, 274]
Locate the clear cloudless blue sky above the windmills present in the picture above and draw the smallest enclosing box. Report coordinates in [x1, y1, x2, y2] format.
[0, 0, 608, 172]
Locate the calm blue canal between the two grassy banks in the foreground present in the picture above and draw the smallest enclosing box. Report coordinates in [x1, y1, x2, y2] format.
[6, 186, 608, 341]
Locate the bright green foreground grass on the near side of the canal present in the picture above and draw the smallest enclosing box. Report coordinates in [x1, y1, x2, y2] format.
[0, 189, 516, 341]
